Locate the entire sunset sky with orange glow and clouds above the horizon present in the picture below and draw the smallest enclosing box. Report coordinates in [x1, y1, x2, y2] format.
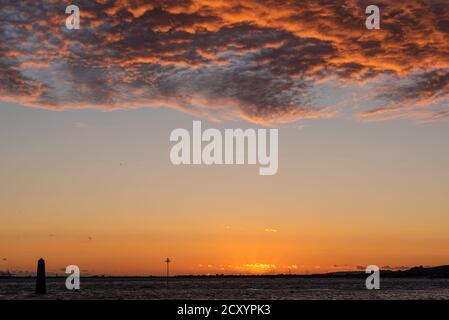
[0, 0, 449, 275]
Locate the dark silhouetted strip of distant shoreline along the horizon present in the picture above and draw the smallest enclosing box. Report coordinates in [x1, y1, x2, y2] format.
[0, 265, 449, 279]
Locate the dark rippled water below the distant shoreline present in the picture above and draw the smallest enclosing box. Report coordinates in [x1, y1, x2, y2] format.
[0, 278, 449, 300]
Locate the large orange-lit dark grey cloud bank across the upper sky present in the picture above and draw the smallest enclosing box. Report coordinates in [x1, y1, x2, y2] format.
[0, 0, 449, 124]
